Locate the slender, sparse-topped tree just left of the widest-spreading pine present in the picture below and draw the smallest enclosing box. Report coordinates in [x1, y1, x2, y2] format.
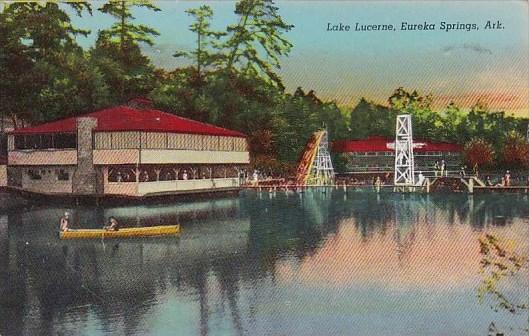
[174, 5, 226, 80]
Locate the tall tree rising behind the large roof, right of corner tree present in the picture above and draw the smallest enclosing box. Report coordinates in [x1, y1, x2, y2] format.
[91, 1, 160, 102]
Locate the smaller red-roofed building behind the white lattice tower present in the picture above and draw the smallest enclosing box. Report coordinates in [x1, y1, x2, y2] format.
[333, 136, 462, 173]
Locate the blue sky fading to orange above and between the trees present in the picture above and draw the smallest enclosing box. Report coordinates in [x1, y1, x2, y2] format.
[74, 0, 529, 117]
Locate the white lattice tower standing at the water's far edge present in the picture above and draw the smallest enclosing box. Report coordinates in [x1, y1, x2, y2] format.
[394, 114, 415, 186]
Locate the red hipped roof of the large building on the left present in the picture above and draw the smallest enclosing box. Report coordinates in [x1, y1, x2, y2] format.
[11, 105, 246, 137]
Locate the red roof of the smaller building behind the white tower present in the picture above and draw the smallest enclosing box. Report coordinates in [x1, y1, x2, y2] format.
[332, 136, 463, 153]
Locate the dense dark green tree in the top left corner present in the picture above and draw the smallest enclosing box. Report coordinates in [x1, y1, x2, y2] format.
[0, 2, 95, 127]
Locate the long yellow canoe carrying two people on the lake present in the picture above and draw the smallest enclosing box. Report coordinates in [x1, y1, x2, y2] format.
[59, 224, 180, 239]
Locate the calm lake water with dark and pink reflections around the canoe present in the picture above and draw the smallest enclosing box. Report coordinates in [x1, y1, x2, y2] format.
[0, 190, 529, 336]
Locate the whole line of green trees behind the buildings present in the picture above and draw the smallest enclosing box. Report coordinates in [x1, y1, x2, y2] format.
[0, 0, 527, 171]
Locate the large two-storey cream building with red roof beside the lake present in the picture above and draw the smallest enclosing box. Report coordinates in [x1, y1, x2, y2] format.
[8, 100, 249, 196]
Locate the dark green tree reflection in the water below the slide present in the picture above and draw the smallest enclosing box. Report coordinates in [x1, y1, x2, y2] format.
[243, 190, 341, 276]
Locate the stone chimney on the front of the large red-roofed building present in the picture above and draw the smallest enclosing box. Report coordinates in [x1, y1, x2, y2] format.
[72, 117, 97, 194]
